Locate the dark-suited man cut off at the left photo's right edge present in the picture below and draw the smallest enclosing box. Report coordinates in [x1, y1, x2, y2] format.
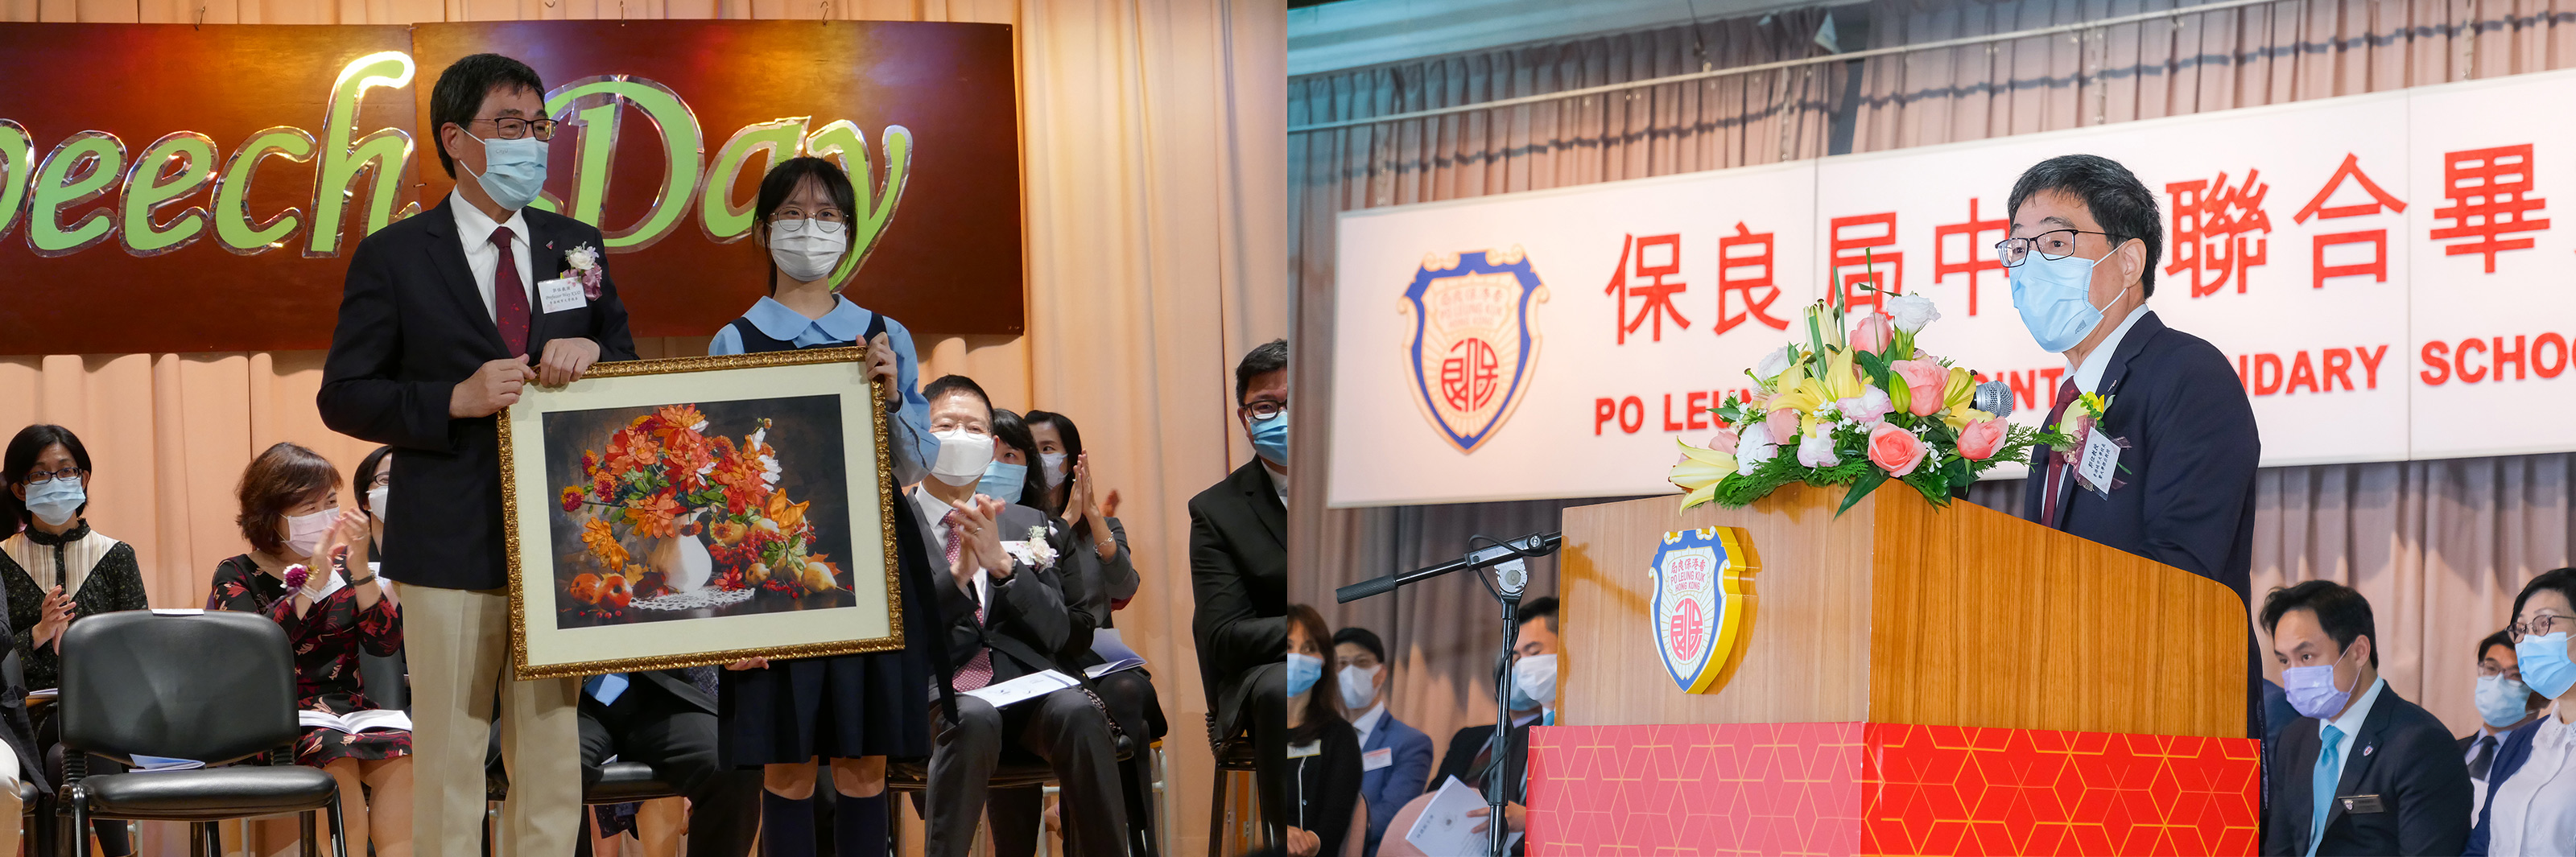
[1190, 340, 1288, 818]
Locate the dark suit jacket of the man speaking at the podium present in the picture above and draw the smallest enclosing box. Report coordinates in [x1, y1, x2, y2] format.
[2022, 309, 2262, 599]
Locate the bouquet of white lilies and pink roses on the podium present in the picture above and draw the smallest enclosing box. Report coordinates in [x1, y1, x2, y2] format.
[1672, 280, 2066, 515]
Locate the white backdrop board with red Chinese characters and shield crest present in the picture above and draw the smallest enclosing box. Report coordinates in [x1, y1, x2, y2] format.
[1329, 72, 2576, 507]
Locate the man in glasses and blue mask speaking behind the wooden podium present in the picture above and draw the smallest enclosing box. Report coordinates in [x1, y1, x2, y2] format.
[1996, 155, 2262, 607]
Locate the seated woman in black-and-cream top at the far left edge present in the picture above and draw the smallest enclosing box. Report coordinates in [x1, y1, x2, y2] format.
[0, 425, 150, 857]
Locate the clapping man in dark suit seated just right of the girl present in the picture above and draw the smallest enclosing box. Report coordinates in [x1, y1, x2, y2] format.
[906, 376, 1125, 857]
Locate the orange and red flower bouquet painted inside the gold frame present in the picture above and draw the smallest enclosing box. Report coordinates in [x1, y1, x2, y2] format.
[559, 404, 845, 620]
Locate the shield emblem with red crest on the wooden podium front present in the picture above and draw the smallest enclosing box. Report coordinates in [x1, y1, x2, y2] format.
[1649, 528, 1762, 692]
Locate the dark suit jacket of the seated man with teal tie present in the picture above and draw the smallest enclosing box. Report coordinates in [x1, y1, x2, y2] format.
[2262, 687, 2471, 857]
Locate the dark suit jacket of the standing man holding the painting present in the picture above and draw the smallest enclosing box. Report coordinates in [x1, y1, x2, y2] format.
[314, 204, 636, 589]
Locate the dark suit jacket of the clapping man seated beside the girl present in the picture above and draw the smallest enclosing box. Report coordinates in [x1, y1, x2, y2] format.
[904, 489, 1082, 685]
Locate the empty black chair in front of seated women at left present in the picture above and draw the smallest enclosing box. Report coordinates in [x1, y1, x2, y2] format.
[60, 610, 348, 857]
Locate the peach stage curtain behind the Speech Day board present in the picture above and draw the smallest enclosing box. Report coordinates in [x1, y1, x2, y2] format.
[0, 0, 1288, 855]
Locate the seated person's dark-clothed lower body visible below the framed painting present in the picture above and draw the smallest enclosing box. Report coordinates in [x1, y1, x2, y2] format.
[580, 666, 760, 857]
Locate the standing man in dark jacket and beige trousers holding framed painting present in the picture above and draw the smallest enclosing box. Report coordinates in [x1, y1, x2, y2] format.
[317, 54, 636, 857]
